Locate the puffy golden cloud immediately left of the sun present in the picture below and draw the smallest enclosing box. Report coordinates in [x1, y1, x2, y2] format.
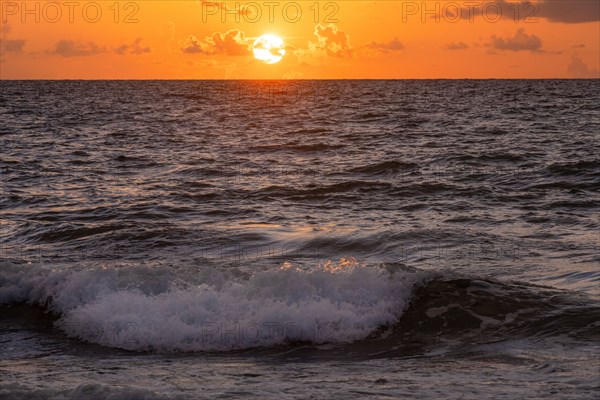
[181, 29, 250, 56]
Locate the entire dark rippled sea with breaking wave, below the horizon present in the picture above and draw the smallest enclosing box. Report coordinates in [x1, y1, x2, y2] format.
[0, 80, 600, 399]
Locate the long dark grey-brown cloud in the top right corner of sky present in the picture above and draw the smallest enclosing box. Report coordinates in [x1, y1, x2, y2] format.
[450, 0, 600, 24]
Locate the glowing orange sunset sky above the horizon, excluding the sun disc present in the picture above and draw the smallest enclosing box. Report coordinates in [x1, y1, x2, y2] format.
[0, 0, 600, 79]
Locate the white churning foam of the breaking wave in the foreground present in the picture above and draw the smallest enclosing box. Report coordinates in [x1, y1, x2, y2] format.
[0, 260, 422, 351]
